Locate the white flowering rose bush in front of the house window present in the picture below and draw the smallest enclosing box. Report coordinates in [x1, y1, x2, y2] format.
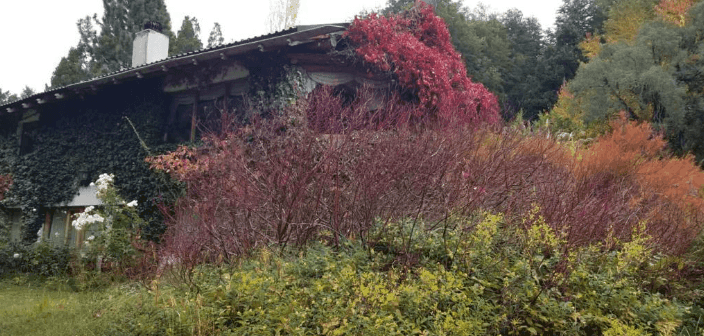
[71, 174, 143, 269]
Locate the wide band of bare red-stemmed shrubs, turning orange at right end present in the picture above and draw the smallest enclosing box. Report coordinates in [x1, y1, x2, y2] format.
[149, 89, 704, 264]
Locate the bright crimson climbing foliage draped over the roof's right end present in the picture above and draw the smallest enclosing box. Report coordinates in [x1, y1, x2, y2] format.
[345, 1, 499, 124]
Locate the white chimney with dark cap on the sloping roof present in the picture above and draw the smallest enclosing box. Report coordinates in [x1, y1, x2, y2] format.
[132, 21, 169, 67]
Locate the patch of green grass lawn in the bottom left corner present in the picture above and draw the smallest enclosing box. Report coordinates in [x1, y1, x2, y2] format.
[0, 276, 138, 335]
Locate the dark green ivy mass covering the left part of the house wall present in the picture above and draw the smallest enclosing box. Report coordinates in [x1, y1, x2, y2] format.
[0, 79, 182, 241]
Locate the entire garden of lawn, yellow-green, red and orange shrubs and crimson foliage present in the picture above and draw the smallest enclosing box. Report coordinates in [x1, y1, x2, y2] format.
[0, 1, 704, 335]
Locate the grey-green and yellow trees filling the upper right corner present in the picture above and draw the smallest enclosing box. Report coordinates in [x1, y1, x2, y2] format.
[546, 0, 704, 164]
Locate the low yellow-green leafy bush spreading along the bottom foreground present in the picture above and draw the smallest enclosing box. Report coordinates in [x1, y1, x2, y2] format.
[107, 210, 688, 335]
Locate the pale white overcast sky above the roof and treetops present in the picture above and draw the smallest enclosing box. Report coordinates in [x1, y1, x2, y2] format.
[0, 0, 562, 94]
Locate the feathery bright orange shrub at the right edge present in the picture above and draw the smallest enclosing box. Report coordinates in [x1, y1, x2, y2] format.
[574, 115, 704, 252]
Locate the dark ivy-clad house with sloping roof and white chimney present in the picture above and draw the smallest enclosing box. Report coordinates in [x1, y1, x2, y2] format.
[0, 23, 390, 245]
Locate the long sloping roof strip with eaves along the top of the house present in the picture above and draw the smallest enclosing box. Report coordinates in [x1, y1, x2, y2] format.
[0, 23, 349, 115]
